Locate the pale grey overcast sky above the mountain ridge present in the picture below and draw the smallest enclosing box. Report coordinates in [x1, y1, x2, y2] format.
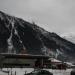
[0, 0, 75, 34]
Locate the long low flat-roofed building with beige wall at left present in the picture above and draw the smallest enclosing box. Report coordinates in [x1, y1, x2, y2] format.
[0, 53, 49, 68]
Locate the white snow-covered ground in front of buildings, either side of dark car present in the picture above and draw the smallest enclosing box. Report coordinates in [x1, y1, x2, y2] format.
[0, 68, 72, 75]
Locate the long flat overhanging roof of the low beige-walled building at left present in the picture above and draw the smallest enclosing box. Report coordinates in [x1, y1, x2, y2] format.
[0, 53, 50, 59]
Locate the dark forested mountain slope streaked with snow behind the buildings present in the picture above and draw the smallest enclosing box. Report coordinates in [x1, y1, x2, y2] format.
[0, 11, 75, 62]
